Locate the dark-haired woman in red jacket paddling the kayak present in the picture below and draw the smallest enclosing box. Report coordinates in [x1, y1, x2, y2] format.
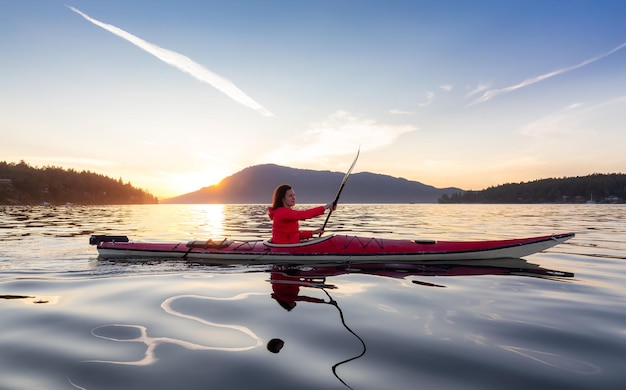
[269, 184, 335, 244]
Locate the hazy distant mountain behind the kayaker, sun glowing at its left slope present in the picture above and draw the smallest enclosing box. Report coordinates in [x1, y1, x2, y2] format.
[160, 164, 463, 204]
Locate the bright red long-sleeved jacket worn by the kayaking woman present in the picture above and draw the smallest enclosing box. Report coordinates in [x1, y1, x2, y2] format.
[269, 206, 324, 244]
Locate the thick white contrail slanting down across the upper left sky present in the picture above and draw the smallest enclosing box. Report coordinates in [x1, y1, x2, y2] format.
[68, 6, 274, 117]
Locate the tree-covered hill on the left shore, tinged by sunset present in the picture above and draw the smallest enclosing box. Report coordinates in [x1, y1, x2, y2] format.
[0, 161, 158, 205]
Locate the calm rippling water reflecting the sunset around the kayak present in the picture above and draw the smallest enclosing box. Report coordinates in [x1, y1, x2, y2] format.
[0, 205, 626, 389]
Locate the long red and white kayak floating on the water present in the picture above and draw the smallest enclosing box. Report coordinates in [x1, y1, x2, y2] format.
[89, 233, 574, 264]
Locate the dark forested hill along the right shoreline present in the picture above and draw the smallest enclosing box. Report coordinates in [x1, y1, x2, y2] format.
[439, 173, 626, 203]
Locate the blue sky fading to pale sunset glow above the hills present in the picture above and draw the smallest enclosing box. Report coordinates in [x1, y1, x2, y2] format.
[0, 0, 626, 199]
